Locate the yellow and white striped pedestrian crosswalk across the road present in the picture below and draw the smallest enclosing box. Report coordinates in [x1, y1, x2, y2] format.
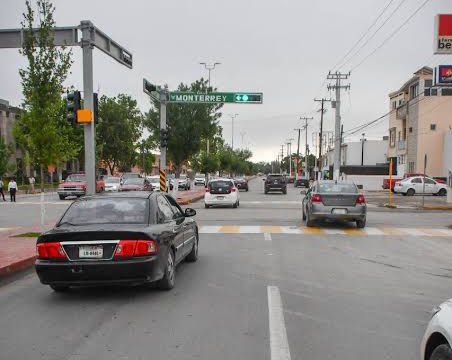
[199, 225, 452, 237]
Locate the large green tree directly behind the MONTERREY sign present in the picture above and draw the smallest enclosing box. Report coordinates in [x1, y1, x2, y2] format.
[145, 78, 223, 174]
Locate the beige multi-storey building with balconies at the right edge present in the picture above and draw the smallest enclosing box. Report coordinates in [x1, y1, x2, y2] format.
[388, 66, 452, 177]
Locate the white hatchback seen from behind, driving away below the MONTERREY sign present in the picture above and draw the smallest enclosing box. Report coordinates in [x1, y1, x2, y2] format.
[204, 179, 240, 209]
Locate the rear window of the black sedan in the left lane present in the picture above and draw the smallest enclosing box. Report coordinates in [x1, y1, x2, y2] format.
[60, 198, 148, 225]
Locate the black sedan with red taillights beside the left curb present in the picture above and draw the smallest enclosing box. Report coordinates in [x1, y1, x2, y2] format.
[35, 191, 199, 291]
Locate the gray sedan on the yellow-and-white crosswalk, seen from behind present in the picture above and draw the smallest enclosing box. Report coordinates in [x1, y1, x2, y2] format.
[301, 180, 367, 228]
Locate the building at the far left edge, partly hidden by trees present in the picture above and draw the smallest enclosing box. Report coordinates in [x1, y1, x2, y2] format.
[0, 99, 25, 180]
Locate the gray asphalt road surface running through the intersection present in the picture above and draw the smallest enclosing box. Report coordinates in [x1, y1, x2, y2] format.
[0, 179, 452, 360]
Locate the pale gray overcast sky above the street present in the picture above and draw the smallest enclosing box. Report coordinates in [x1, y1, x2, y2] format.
[0, 0, 452, 160]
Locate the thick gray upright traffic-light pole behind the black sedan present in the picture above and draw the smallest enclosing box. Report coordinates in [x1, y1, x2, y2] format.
[80, 21, 96, 195]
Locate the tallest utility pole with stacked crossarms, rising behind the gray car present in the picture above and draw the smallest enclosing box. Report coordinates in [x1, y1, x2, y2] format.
[327, 71, 350, 180]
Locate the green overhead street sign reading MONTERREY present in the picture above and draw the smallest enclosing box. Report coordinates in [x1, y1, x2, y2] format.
[169, 91, 263, 104]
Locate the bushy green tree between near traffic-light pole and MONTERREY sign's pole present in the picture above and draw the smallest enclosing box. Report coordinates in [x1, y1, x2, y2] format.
[96, 94, 143, 174]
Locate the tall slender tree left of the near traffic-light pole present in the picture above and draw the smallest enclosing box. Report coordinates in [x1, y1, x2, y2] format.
[14, 0, 77, 188]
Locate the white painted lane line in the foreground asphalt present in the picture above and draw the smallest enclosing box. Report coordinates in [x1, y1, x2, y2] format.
[267, 286, 290, 360]
